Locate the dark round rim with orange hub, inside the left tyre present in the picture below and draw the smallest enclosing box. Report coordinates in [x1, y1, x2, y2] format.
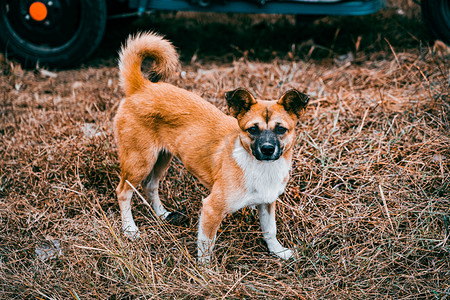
[0, 0, 82, 53]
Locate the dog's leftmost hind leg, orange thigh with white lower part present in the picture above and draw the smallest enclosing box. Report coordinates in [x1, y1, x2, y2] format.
[116, 152, 158, 239]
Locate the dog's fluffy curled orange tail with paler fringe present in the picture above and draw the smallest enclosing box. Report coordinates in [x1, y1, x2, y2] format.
[119, 32, 179, 96]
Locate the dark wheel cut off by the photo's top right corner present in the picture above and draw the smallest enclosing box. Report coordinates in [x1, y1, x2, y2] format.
[420, 0, 450, 45]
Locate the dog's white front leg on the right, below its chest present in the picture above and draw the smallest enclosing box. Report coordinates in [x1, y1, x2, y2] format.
[258, 202, 294, 259]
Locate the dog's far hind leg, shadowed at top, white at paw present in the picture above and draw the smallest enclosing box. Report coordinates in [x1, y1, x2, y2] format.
[142, 150, 173, 219]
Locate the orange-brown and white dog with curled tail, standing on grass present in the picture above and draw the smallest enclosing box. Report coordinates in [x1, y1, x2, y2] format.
[115, 33, 308, 262]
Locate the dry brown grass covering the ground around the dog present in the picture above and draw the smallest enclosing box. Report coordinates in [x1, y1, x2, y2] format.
[0, 3, 450, 299]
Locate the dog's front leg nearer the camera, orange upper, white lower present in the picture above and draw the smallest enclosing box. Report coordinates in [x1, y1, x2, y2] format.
[197, 194, 225, 264]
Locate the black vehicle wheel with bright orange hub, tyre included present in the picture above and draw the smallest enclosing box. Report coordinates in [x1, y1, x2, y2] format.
[0, 0, 107, 68]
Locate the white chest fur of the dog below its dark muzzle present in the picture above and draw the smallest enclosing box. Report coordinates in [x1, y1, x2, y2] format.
[231, 139, 289, 211]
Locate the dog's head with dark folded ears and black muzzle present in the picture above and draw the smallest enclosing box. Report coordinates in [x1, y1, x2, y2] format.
[225, 88, 309, 161]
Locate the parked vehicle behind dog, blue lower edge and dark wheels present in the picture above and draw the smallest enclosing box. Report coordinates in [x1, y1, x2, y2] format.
[0, 0, 450, 68]
